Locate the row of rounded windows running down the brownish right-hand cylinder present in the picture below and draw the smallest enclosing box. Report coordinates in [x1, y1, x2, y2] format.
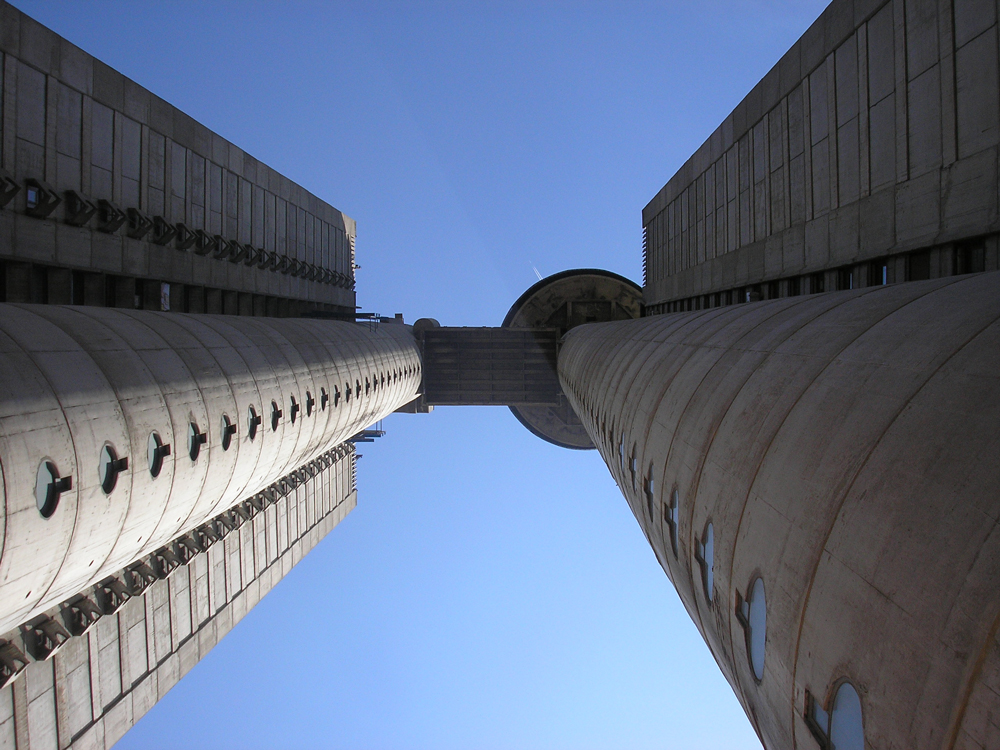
[570, 383, 865, 750]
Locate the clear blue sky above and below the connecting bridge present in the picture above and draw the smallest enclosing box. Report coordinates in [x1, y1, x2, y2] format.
[15, 0, 825, 750]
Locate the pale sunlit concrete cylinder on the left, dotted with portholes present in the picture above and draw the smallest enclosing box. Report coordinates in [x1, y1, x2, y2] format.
[0, 305, 421, 632]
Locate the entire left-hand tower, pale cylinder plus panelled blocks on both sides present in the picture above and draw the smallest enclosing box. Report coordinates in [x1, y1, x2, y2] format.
[0, 2, 422, 749]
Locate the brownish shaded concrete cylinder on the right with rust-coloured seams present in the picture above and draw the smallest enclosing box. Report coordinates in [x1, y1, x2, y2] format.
[559, 273, 1000, 750]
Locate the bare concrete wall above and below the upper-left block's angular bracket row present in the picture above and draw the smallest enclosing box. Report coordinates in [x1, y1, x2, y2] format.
[0, 0, 356, 309]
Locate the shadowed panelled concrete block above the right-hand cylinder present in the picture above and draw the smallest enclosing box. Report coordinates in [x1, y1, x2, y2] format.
[642, 0, 1000, 307]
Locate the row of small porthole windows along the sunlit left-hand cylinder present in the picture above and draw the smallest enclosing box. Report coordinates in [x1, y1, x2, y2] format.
[35, 365, 419, 518]
